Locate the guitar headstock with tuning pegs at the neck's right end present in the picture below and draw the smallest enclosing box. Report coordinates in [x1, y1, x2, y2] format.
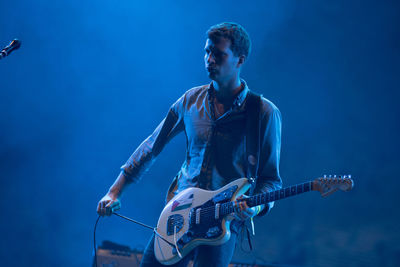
[312, 175, 354, 197]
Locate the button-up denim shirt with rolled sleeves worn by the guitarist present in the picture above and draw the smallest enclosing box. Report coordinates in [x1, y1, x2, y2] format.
[121, 80, 282, 216]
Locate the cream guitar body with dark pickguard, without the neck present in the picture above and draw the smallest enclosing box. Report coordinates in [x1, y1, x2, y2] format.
[154, 178, 250, 265]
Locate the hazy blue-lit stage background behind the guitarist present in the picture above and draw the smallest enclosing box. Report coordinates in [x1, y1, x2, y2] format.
[0, 0, 400, 267]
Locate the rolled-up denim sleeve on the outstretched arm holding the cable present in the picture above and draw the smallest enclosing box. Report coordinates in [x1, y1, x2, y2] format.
[121, 96, 184, 182]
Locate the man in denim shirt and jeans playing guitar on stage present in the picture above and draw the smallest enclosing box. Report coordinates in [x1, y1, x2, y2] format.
[97, 23, 281, 267]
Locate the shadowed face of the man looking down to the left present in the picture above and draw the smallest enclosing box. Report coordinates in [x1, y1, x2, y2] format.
[204, 38, 242, 82]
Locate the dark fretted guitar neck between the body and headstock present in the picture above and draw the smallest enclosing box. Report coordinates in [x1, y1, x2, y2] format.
[220, 181, 312, 216]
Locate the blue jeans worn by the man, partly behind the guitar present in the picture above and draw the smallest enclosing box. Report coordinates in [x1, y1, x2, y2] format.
[140, 231, 237, 267]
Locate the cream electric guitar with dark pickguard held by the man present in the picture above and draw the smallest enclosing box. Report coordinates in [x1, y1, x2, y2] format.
[154, 175, 354, 265]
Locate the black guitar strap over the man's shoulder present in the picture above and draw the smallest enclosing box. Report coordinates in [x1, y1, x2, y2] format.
[245, 91, 261, 196]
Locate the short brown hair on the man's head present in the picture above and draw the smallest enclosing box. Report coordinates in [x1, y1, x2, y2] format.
[207, 22, 251, 57]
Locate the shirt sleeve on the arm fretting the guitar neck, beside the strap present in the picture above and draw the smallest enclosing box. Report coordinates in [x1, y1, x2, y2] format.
[255, 103, 282, 216]
